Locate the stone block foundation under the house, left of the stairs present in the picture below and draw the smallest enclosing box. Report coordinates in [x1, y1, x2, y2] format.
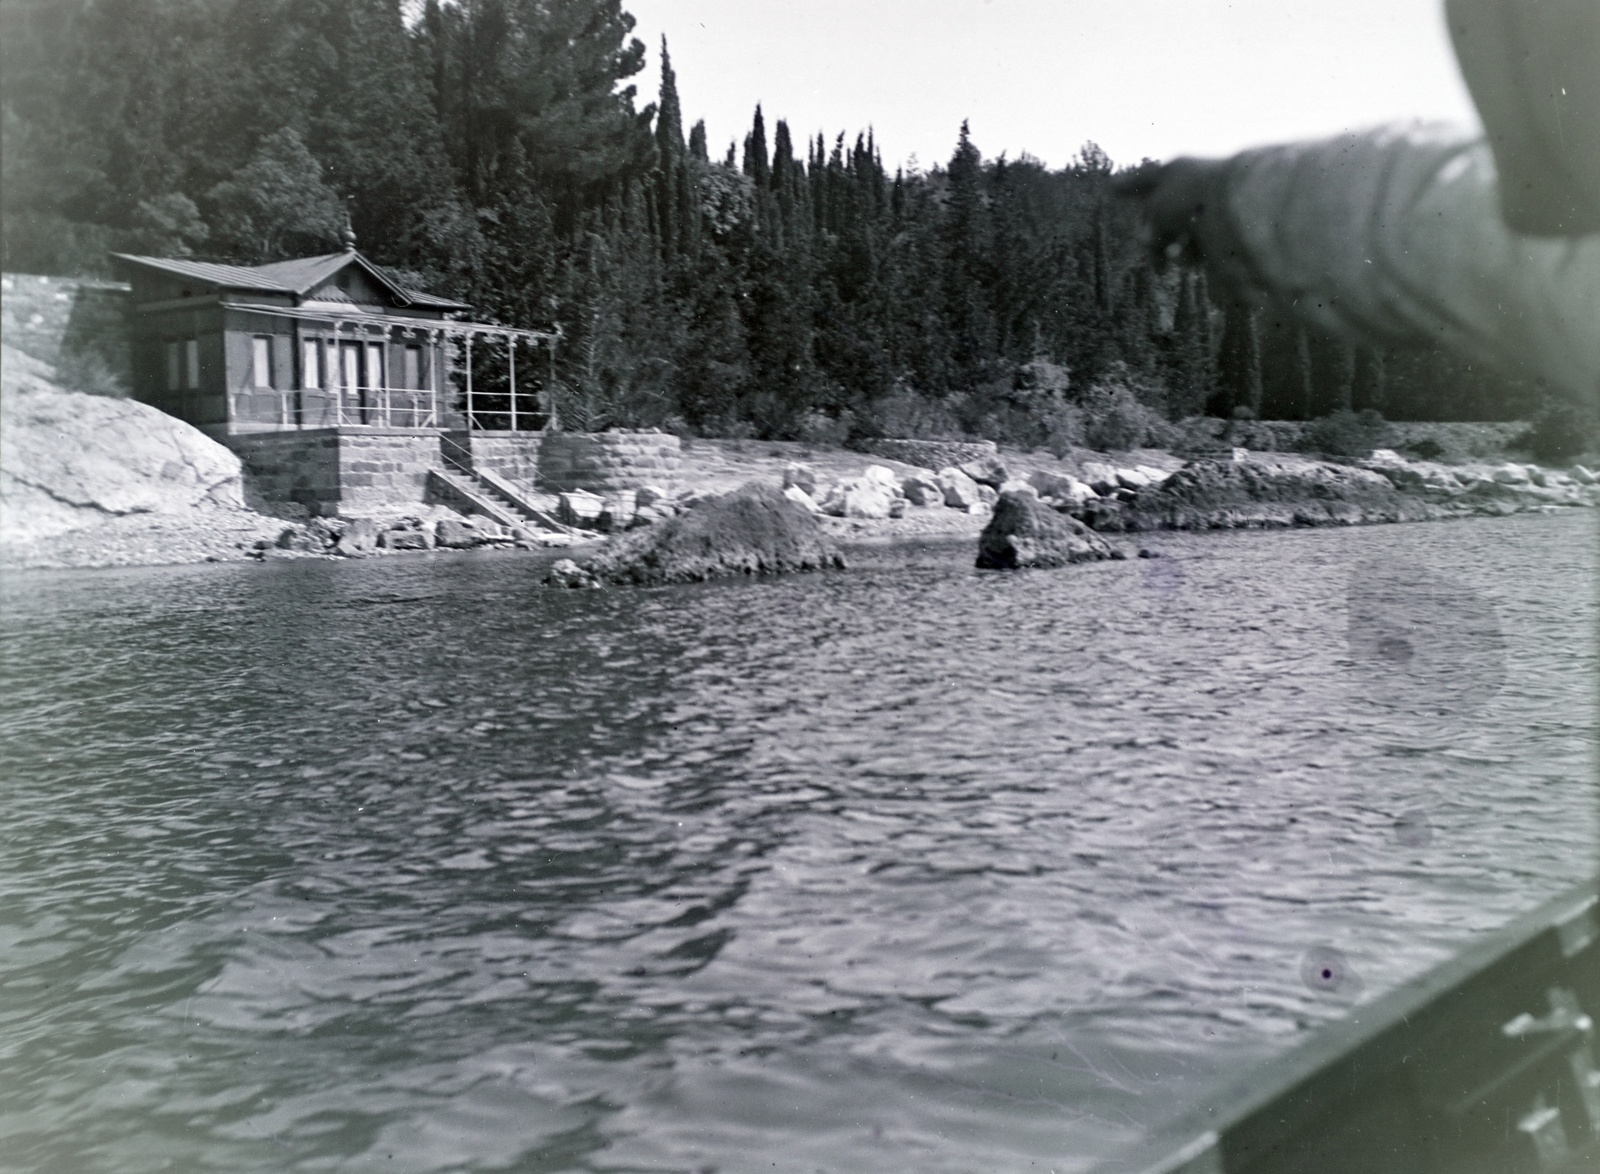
[226, 429, 442, 517]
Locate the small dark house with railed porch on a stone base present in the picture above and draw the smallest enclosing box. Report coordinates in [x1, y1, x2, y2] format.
[103, 230, 558, 515]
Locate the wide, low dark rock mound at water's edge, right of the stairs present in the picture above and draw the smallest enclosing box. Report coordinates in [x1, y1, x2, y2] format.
[586, 481, 845, 584]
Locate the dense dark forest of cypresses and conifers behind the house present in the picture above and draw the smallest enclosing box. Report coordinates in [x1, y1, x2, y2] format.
[0, 0, 1536, 445]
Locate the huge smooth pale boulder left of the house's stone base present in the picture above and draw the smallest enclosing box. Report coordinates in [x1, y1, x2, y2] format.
[0, 347, 245, 542]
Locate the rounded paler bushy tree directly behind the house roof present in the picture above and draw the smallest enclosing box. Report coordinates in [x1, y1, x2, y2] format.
[208, 126, 344, 262]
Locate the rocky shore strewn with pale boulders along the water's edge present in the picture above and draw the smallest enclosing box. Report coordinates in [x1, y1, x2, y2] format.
[0, 340, 1600, 582]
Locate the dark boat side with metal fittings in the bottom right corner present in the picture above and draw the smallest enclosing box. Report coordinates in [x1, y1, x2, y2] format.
[1096, 880, 1600, 1174]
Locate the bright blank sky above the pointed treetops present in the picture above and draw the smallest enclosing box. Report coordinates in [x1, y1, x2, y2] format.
[624, 0, 1477, 168]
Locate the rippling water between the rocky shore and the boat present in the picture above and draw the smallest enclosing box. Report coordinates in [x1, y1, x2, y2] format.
[0, 515, 1600, 1174]
